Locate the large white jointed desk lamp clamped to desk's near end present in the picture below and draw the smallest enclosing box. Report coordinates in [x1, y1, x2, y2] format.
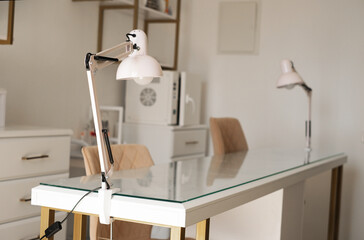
[85, 30, 163, 224]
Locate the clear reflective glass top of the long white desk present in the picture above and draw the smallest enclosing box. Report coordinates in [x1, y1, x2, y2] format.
[41, 149, 344, 203]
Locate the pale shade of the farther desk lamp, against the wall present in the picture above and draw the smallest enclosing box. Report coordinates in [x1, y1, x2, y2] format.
[277, 59, 305, 89]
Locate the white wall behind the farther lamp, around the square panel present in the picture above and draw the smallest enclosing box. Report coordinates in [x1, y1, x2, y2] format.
[180, 0, 364, 240]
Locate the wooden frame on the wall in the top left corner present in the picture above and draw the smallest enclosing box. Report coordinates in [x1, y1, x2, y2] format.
[0, 0, 15, 44]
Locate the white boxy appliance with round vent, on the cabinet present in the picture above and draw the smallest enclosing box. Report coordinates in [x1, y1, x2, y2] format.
[125, 71, 201, 126]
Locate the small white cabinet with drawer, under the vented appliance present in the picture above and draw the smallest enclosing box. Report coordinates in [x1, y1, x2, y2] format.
[123, 123, 208, 163]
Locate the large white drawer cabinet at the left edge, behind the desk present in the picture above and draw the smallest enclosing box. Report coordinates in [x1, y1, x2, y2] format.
[0, 126, 72, 239]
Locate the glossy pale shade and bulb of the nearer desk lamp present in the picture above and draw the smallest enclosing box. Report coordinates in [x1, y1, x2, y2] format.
[116, 30, 163, 85]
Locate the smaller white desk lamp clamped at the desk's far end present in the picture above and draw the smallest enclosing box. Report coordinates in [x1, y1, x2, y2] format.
[277, 59, 312, 156]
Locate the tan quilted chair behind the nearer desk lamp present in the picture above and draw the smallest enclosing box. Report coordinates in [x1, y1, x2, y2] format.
[82, 144, 154, 240]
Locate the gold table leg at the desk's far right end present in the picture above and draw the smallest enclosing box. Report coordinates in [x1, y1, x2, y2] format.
[327, 166, 343, 240]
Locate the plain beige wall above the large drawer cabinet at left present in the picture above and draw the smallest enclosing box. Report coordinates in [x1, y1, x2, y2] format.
[0, 0, 125, 136]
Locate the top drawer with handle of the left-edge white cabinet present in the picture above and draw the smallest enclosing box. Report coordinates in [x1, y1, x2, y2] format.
[0, 136, 70, 180]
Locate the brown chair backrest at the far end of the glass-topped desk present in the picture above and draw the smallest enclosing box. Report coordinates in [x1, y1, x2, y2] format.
[210, 118, 248, 155]
